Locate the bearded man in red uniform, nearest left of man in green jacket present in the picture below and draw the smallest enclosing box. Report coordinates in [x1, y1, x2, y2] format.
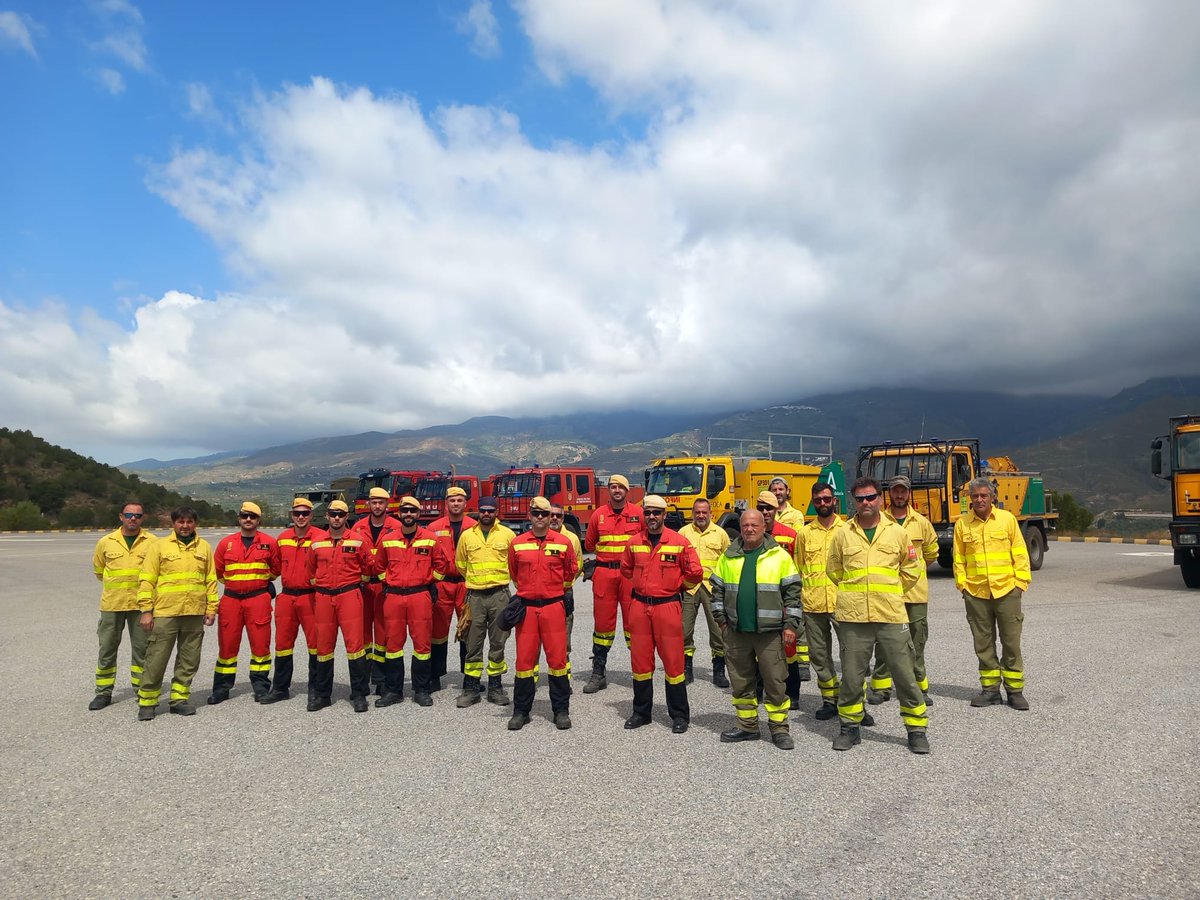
[620, 494, 704, 734]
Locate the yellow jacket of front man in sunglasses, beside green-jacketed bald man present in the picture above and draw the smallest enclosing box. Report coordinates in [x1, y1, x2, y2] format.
[826, 516, 922, 623]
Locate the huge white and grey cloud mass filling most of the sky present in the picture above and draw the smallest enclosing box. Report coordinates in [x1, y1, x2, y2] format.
[0, 0, 1200, 458]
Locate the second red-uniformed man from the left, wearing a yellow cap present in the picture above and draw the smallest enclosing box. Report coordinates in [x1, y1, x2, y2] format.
[263, 497, 329, 703]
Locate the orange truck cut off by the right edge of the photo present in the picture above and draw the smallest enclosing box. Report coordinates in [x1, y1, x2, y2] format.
[1150, 415, 1200, 588]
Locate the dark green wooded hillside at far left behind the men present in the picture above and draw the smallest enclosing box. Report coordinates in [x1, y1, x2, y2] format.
[0, 428, 234, 530]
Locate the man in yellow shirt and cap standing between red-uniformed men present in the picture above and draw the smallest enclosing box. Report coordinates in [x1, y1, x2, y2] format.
[455, 497, 516, 708]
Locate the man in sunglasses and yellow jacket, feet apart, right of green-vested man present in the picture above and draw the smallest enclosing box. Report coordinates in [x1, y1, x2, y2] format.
[826, 476, 929, 754]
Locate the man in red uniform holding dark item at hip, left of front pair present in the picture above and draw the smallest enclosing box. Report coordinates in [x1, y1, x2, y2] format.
[509, 497, 576, 731]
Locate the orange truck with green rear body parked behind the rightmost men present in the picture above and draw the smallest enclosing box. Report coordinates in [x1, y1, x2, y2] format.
[856, 438, 1058, 571]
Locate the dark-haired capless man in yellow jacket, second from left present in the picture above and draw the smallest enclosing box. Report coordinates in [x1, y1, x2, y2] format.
[138, 506, 218, 721]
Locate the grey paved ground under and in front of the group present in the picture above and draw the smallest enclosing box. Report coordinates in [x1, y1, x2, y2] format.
[0, 534, 1200, 898]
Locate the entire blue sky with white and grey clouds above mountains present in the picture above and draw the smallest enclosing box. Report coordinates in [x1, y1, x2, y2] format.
[0, 0, 1200, 462]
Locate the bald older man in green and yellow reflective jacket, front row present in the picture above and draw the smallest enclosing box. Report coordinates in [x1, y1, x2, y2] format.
[712, 510, 803, 750]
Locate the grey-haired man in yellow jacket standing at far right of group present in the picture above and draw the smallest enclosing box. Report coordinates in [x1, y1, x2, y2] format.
[954, 478, 1031, 709]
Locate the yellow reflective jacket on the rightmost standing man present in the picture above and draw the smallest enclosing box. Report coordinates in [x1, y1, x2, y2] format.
[954, 508, 1030, 600]
